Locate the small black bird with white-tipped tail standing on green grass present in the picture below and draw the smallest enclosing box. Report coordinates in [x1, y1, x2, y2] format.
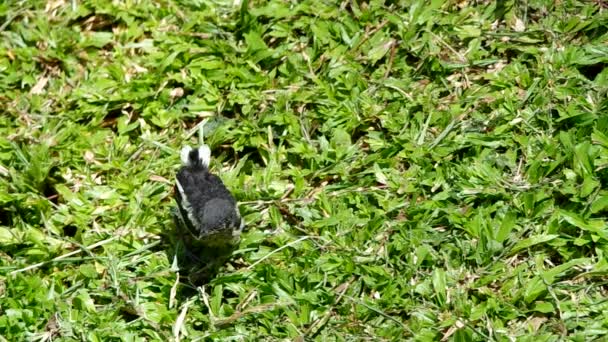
[175, 145, 244, 261]
